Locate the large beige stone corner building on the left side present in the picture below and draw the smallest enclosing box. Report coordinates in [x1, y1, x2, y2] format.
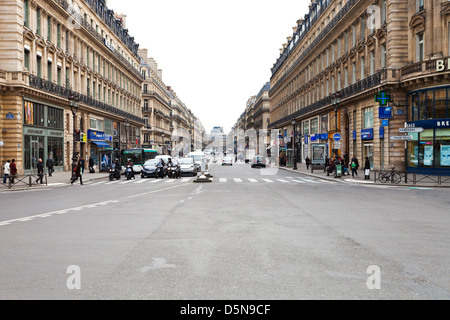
[0, 0, 144, 174]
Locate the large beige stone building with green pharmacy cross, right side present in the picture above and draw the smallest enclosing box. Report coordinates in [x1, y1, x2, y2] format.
[270, 0, 449, 175]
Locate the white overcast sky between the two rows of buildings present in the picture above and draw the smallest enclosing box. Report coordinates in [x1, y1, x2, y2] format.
[108, 0, 310, 133]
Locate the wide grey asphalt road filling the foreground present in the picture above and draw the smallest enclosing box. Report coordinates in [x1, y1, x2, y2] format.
[0, 157, 450, 300]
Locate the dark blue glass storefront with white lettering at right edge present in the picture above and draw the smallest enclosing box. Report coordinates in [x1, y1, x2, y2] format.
[406, 86, 450, 174]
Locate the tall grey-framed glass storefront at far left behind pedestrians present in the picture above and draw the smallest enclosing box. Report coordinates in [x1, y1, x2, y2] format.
[23, 100, 64, 174]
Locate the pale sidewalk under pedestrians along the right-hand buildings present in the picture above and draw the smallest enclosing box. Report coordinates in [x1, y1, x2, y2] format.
[279, 163, 450, 188]
